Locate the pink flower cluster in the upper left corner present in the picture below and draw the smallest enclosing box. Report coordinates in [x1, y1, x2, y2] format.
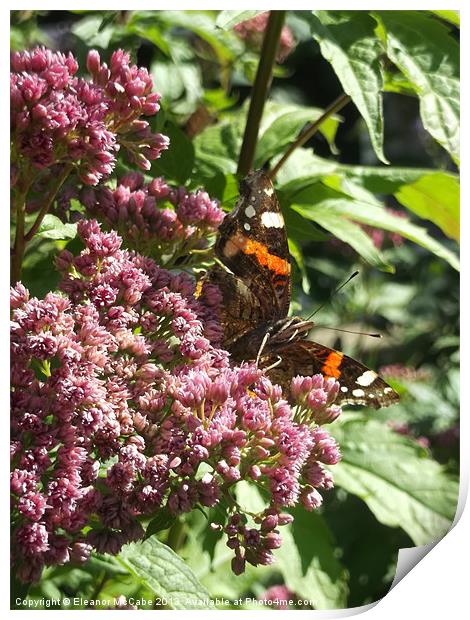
[10, 47, 169, 185]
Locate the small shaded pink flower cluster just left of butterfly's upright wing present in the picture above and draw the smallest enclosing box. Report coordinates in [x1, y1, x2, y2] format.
[80, 172, 224, 265]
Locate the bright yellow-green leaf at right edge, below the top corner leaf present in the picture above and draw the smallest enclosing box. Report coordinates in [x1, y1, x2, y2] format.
[395, 172, 460, 241]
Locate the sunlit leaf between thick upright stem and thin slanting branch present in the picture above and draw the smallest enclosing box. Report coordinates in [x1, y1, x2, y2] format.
[255, 103, 339, 168]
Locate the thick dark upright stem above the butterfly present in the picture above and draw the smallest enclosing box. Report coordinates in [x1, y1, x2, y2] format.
[237, 11, 286, 176]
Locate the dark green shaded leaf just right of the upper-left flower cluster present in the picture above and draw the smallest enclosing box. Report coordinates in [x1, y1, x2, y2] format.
[152, 125, 194, 185]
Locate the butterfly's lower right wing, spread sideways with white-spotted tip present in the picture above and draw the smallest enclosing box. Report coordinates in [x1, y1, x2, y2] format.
[262, 340, 399, 409]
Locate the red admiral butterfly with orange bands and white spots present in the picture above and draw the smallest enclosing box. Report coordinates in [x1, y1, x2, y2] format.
[205, 170, 398, 408]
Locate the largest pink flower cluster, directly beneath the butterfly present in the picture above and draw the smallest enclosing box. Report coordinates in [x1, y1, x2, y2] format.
[11, 220, 340, 582]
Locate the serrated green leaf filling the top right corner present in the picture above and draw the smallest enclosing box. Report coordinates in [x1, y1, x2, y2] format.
[377, 11, 460, 163]
